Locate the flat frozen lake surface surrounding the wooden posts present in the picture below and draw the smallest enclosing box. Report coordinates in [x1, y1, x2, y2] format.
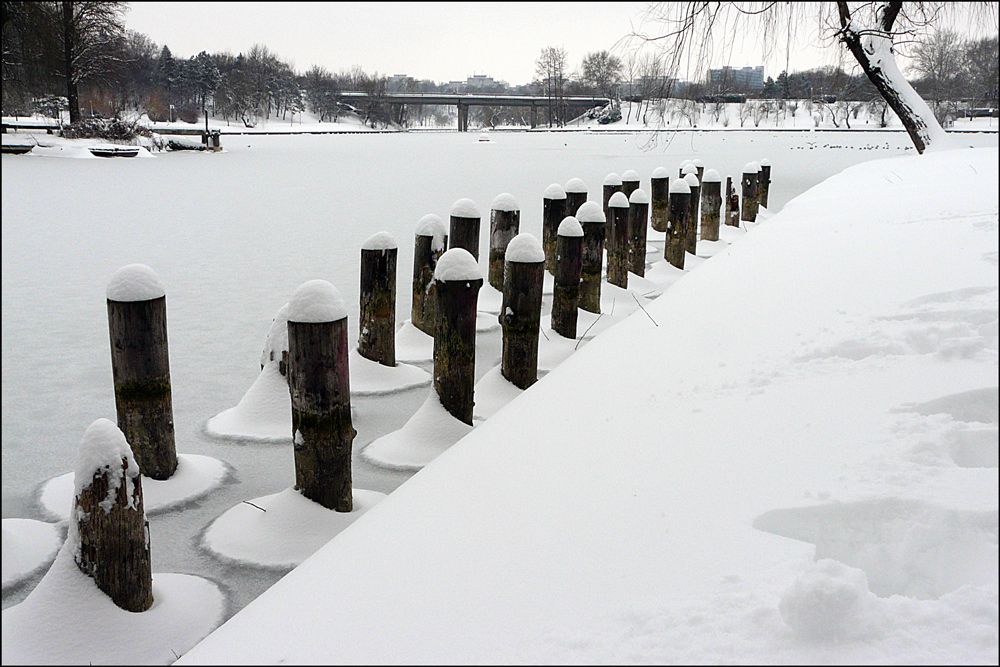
[2, 126, 997, 615]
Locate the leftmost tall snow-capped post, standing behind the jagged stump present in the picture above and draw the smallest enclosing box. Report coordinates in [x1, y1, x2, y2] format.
[106, 264, 177, 481]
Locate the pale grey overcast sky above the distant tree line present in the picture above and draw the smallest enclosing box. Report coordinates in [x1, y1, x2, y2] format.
[125, 2, 984, 85]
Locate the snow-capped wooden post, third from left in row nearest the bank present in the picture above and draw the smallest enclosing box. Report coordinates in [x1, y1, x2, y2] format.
[434, 248, 483, 426]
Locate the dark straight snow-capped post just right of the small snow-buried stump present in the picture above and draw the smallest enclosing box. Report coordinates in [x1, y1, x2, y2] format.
[358, 232, 397, 366]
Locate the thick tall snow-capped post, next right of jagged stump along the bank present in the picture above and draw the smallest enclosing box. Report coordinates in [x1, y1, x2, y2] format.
[288, 280, 357, 512]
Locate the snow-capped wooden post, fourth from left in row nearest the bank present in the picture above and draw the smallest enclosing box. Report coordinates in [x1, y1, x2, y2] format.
[499, 233, 558, 389]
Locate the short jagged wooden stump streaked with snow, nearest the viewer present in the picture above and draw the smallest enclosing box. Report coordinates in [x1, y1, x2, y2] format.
[70, 452, 153, 612]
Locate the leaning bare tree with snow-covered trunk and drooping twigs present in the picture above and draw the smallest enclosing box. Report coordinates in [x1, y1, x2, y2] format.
[631, 0, 997, 153]
